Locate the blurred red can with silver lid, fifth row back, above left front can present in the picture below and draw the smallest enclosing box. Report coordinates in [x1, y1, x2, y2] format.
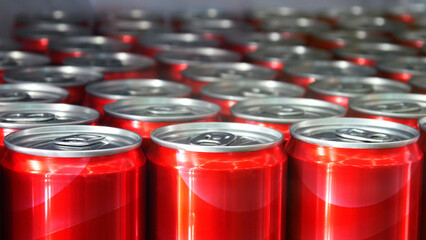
[64, 52, 157, 80]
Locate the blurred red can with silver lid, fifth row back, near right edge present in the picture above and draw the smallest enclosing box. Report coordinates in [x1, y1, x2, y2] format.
[334, 43, 418, 67]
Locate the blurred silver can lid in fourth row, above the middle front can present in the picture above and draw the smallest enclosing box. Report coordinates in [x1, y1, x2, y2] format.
[182, 63, 276, 82]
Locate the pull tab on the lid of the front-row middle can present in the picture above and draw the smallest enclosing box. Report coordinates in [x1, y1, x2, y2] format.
[189, 132, 237, 146]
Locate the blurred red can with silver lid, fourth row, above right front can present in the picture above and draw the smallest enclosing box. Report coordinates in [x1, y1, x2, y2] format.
[282, 61, 376, 88]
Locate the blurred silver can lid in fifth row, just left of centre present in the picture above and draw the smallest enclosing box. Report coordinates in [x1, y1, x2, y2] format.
[156, 47, 241, 64]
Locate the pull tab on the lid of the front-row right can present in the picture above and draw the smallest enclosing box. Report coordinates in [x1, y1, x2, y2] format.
[335, 128, 395, 143]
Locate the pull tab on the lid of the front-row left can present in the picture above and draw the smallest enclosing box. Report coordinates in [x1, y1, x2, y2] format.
[53, 134, 105, 147]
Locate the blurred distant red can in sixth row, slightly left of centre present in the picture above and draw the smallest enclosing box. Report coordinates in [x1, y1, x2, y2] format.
[137, 33, 219, 57]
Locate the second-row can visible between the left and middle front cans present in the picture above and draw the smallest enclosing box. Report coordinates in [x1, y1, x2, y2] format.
[102, 97, 220, 151]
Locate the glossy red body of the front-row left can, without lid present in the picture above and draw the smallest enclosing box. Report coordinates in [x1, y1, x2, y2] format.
[0, 149, 146, 240]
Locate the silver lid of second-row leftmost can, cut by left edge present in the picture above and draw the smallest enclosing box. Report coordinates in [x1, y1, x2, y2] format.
[0, 103, 99, 129]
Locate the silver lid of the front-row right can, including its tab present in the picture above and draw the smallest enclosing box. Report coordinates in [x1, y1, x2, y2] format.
[290, 118, 420, 149]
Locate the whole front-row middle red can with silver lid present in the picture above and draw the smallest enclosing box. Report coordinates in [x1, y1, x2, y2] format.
[147, 122, 287, 240]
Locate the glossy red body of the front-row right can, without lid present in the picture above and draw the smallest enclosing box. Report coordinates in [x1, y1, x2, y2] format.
[286, 138, 423, 240]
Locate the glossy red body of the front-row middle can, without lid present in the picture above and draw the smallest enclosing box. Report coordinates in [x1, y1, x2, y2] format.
[147, 144, 287, 240]
